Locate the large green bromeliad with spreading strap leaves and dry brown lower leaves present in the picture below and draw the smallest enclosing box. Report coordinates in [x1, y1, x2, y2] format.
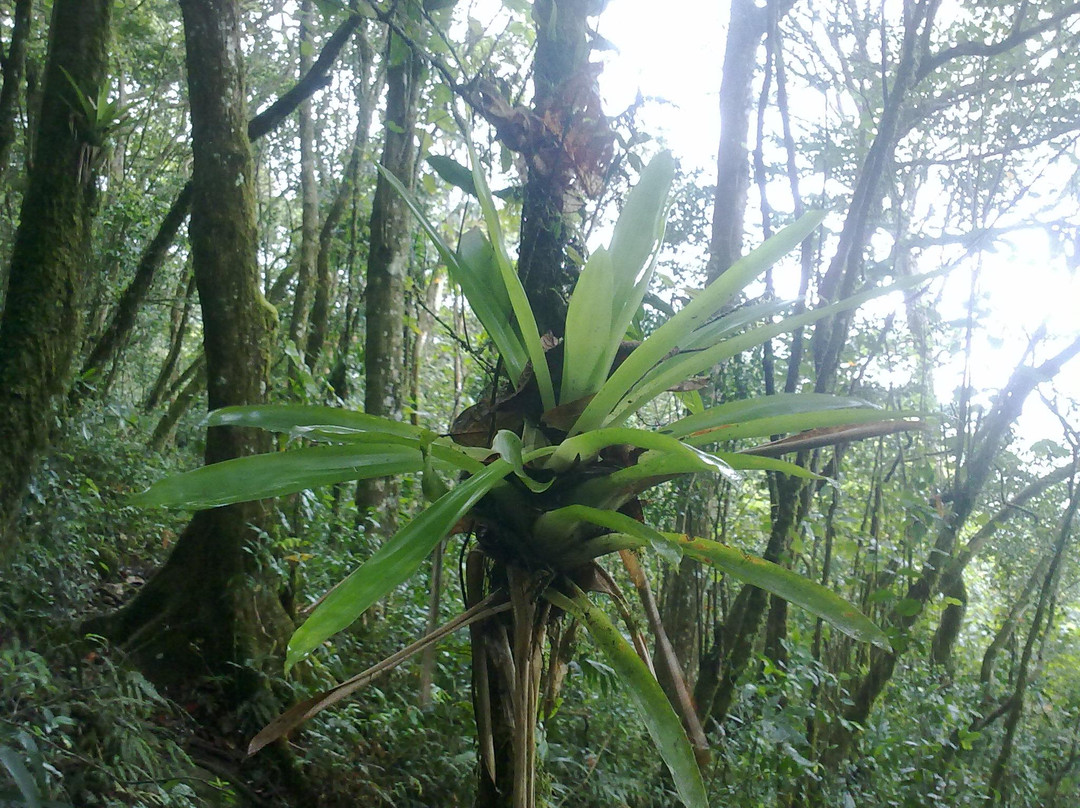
[140, 147, 924, 808]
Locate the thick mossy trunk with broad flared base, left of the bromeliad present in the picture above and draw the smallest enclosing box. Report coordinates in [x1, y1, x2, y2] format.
[89, 0, 292, 708]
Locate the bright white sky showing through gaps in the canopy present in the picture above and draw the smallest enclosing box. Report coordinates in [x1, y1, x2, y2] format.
[597, 0, 1080, 440]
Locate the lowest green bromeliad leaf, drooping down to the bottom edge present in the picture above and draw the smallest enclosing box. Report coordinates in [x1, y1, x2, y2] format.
[544, 584, 708, 808]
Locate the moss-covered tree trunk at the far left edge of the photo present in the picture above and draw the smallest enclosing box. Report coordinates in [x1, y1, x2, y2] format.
[0, 0, 112, 551]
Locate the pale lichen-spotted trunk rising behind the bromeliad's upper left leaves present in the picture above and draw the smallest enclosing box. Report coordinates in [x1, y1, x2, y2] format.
[356, 28, 422, 527]
